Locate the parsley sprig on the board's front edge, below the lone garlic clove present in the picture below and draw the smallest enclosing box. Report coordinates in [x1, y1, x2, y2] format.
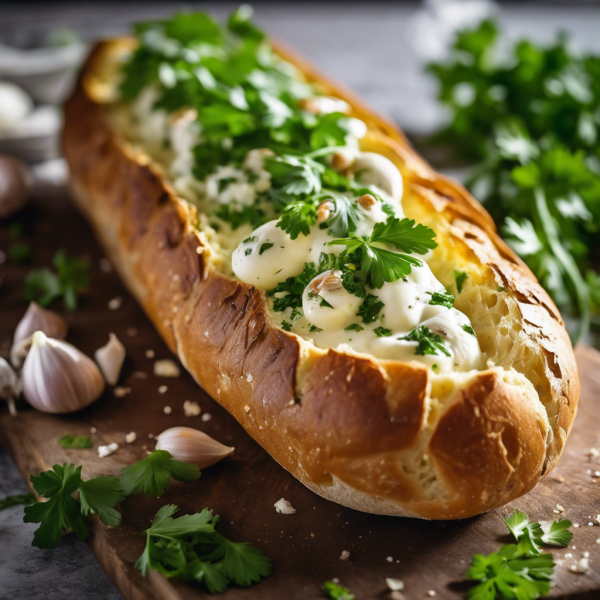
[135, 504, 273, 594]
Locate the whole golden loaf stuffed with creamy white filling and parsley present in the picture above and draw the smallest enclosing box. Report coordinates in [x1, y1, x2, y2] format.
[63, 9, 579, 519]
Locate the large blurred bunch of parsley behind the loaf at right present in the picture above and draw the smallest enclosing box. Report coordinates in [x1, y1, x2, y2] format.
[429, 20, 600, 340]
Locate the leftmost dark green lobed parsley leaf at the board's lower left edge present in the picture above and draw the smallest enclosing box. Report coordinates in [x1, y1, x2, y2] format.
[23, 464, 89, 548]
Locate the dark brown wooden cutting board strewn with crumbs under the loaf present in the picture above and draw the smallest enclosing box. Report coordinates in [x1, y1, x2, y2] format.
[0, 198, 600, 600]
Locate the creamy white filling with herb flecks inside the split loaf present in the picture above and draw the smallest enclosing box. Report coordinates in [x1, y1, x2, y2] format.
[116, 87, 483, 372]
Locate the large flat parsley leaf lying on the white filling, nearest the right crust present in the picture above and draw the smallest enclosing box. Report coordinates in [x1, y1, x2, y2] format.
[329, 217, 437, 288]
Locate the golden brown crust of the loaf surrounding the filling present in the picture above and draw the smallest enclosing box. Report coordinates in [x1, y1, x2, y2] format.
[63, 42, 579, 519]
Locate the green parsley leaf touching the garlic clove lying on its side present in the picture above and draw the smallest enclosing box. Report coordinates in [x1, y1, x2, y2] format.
[121, 450, 200, 497]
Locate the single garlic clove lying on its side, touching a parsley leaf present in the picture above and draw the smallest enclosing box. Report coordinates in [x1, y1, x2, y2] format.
[156, 427, 234, 469]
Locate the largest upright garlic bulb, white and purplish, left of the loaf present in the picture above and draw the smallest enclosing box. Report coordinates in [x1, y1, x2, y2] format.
[22, 331, 104, 413]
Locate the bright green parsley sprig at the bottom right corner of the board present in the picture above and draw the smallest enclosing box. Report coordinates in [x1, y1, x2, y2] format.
[466, 510, 573, 600]
